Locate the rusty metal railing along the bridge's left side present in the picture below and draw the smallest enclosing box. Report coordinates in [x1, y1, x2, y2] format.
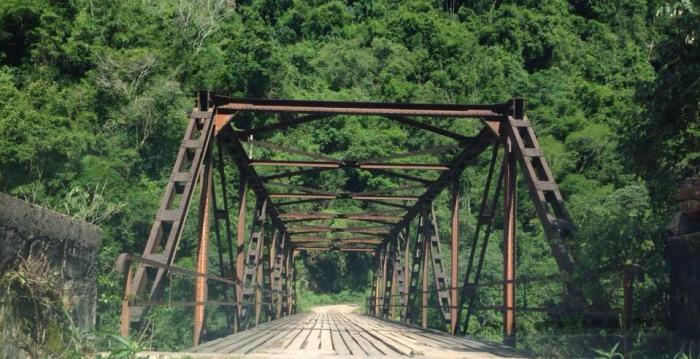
[115, 253, 296, 337]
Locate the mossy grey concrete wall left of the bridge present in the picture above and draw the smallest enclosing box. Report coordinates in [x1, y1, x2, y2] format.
[0, 193, 100, 329]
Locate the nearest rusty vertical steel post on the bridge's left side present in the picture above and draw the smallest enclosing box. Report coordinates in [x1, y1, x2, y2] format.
[192, 152, 212, 345]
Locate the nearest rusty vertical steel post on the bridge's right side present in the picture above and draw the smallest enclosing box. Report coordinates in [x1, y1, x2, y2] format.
[503, 140, 517, 346]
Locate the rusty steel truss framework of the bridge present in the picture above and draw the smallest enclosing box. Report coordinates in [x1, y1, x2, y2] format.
[117, 91, 636, 356]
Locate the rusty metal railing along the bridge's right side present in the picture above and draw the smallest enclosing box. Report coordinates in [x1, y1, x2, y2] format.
[366, 264, 642, 349]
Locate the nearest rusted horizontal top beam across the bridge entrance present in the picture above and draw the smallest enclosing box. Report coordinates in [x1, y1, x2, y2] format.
[212, 95, 507, 118]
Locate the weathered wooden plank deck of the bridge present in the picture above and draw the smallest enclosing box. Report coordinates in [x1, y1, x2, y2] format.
[186, 312, 524, 358]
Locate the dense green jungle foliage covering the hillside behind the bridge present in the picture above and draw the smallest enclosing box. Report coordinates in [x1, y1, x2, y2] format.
[0, 0, 700, 357]
